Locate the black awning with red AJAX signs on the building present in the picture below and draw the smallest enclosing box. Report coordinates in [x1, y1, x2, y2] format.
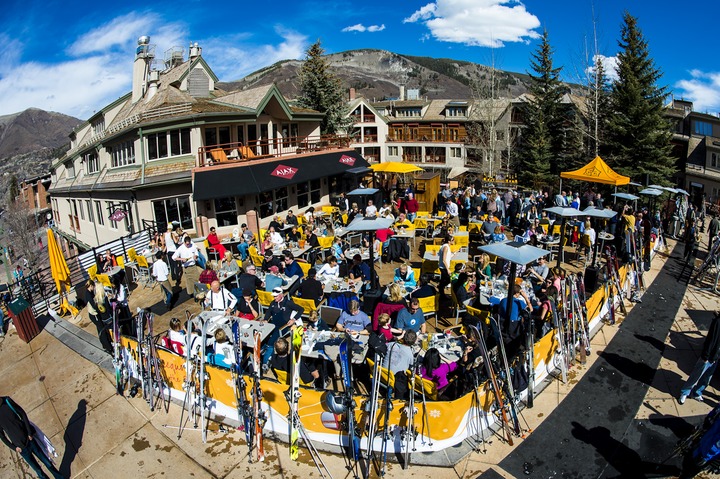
[193, 150, 368, 201]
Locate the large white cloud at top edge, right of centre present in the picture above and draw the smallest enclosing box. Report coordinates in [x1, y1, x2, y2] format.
[403, 0, 540, 47]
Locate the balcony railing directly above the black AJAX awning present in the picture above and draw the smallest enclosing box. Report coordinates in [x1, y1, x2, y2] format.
[196, 135, 350, 166]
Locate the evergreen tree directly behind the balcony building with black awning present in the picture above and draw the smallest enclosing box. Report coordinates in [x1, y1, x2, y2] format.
[298, 40, 352, 134]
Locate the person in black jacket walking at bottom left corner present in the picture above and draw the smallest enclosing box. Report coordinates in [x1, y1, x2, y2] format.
[0, 396, 63, 479]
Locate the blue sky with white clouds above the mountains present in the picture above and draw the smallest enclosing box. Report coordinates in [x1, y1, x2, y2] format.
[0, 0, 720, 119]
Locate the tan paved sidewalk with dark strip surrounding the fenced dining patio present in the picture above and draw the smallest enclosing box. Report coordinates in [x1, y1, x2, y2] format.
[0, 237, 720, 479]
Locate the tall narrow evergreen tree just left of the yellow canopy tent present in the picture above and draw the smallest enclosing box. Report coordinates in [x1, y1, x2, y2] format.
[520, 30, 569, 186]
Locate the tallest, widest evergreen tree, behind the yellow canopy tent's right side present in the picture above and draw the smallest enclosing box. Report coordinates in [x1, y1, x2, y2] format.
[606, 12, 676, 184]
